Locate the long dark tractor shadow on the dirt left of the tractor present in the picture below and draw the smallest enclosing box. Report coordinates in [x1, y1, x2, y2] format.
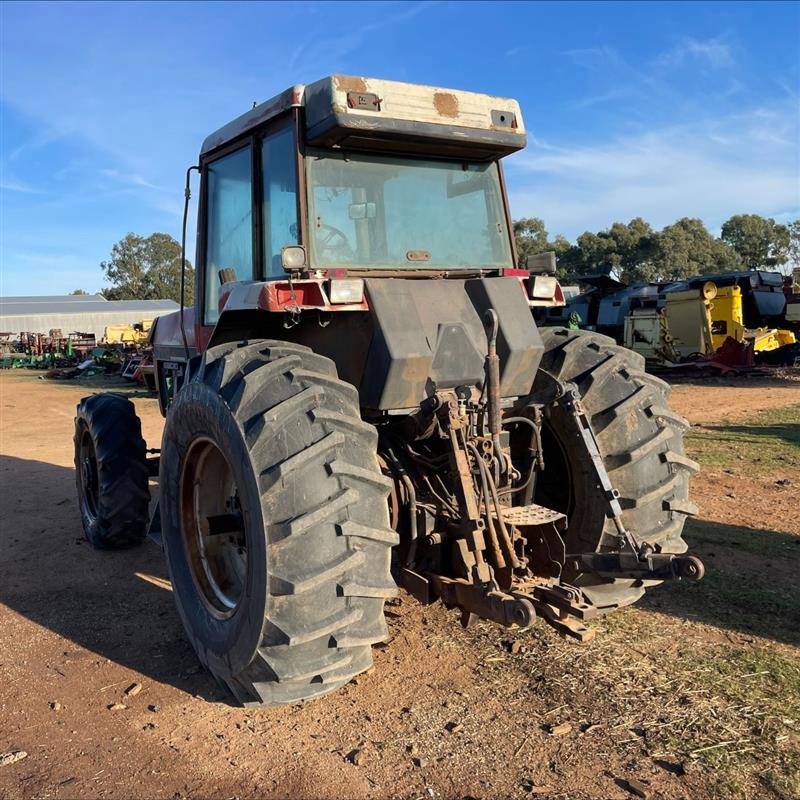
[0, 456, 225, 701]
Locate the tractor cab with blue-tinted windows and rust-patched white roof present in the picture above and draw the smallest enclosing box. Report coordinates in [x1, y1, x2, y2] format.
[198, 75, 525, 324]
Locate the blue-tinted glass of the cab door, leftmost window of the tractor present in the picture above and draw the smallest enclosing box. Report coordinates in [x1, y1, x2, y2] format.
[204, 146, 254, 325]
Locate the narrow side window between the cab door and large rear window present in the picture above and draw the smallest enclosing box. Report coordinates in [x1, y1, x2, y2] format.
[261, 128, 299, 278]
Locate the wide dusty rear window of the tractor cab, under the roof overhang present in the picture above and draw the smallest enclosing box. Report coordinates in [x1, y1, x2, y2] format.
[306, 150, 512, 269]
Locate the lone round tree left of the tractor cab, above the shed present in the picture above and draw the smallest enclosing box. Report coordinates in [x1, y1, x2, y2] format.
[100, 233, 194, 305]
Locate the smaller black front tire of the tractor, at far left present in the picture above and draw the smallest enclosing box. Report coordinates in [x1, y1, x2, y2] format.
[74, 393, 150, 550]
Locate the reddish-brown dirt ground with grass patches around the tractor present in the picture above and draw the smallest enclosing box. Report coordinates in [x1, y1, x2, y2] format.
[0, 371, 800, 799]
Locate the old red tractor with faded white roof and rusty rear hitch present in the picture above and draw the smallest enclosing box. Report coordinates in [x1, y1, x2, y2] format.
[75, 75, 703, 706]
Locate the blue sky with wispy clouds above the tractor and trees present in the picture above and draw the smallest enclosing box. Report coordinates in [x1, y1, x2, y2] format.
[0, 2, 800, 295]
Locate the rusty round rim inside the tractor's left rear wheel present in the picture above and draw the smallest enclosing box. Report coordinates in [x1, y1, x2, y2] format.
[179, 439, 247, 619]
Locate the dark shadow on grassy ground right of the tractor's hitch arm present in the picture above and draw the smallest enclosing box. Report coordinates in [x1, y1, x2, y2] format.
[640, 519, 800, 645]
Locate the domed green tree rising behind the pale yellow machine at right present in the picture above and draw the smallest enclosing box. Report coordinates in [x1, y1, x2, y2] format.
[653, 217, 741, 280]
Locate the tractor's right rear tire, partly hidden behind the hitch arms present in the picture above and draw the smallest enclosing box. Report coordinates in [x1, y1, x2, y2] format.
[536, 328, 698, 610]
